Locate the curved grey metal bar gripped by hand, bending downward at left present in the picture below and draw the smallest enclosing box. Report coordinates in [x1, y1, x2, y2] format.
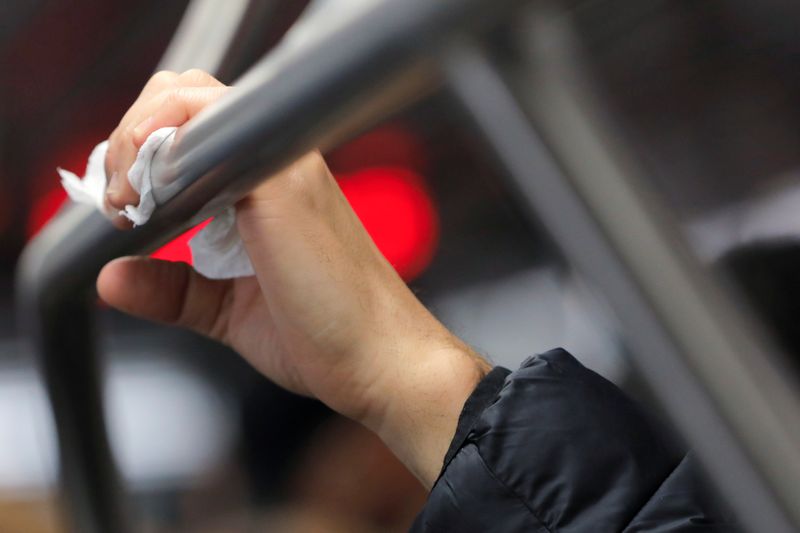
[17, 0, 514, 533]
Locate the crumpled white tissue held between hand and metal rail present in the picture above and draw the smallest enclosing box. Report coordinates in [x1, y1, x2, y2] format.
[58, 128, 254, 279]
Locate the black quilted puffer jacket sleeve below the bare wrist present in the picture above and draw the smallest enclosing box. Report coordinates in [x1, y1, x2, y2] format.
[412, 349, 730, 532]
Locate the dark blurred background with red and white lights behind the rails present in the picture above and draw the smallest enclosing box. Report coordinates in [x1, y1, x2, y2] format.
[0, 0, 800, 533]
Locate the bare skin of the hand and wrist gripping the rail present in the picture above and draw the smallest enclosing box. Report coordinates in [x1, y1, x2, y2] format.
[97, 70, 489, 488]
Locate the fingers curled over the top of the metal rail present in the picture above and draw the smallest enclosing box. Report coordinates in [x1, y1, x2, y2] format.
[105, 70, 225, 216]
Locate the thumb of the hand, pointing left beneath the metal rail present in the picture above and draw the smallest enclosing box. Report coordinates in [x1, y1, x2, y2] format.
[97, 257, 232, 342]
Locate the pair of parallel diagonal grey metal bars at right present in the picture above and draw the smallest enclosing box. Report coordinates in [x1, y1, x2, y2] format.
[444, 32, 800, 533]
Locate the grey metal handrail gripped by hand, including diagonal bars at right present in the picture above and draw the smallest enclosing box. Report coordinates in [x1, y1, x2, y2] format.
[18, 0, 800, 533]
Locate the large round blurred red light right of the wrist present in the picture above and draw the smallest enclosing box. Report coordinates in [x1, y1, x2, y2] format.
[339, 167, 439, 280]
